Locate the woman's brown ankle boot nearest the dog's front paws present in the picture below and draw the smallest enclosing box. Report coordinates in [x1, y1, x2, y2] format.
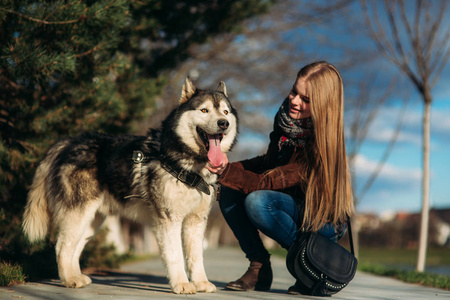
[226, 260, 273, 291]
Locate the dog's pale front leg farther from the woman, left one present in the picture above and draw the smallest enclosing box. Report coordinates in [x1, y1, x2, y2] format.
[156, 219, 197, 294]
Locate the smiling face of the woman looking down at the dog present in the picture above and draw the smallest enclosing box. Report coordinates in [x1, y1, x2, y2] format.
[288, 78, 311, 120]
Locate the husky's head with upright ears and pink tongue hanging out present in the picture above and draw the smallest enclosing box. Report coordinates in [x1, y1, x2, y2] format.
[165, 77, 238, 165]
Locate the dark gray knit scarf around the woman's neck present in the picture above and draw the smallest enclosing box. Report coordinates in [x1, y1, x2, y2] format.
[274, 98, 314, 149]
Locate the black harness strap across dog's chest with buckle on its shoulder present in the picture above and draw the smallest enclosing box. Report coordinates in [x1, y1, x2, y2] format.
[132, 151, 211, 195]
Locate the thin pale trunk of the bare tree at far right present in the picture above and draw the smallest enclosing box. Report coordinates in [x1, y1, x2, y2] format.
[416, 101, 431, 272]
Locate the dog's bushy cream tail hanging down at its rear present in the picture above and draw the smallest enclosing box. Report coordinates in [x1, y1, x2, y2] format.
[22, 157, 51, 242]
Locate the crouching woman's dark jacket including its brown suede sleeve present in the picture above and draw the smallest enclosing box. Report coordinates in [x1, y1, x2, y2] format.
[218, 132, 305, 202]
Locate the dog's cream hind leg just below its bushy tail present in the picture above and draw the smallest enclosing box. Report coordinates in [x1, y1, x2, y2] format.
[56, 203, 98, 288]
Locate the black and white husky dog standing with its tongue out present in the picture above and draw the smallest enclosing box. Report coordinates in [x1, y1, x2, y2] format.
[23, 78, 238, 294]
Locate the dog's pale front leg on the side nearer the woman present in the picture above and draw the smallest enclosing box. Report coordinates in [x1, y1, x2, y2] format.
[182, 214, 216, 293]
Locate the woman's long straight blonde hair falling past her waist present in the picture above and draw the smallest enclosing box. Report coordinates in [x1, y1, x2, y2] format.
[297, 61, 354, 231]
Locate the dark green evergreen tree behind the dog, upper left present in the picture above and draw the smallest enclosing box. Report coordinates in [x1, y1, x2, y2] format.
[0, 0, 271, 264]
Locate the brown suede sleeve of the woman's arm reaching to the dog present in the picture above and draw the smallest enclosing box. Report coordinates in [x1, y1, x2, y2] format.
[218, 162, 301, 194]
